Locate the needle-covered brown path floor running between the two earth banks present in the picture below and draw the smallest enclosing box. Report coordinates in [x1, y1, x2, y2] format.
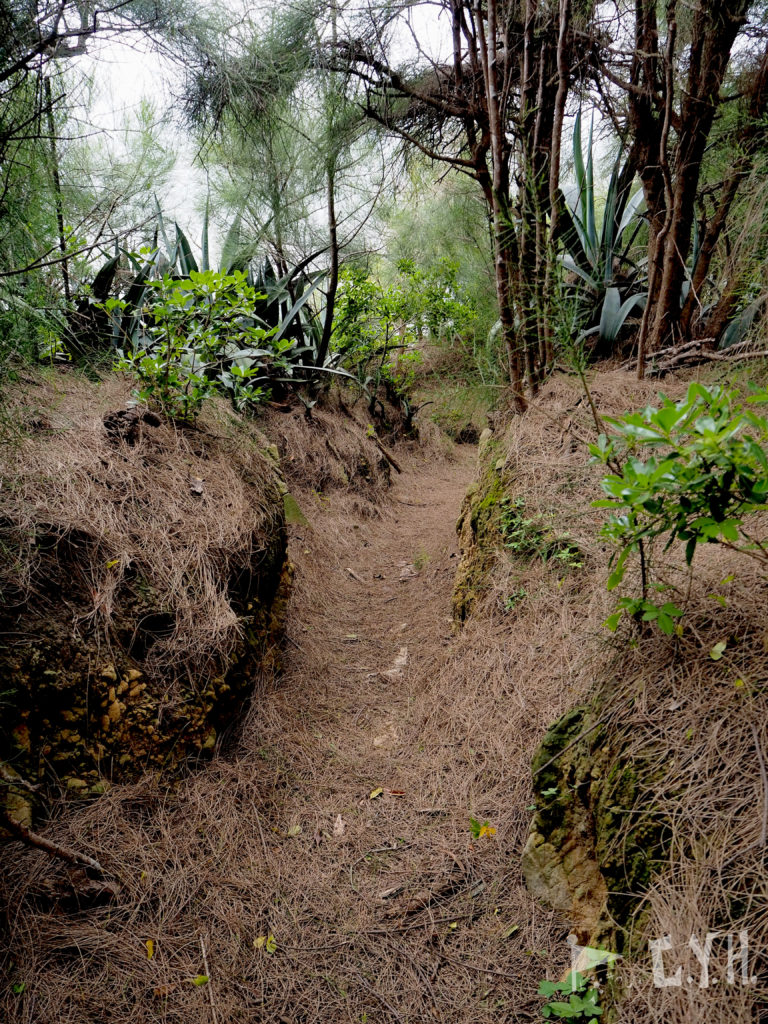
[0, 436, 571, 1024]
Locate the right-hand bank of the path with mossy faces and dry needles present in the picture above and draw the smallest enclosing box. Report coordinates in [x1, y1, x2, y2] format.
[455, 374, 768, 1022]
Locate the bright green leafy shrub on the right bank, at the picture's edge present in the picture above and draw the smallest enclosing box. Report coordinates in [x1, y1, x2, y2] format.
[590, 382, 768, 634]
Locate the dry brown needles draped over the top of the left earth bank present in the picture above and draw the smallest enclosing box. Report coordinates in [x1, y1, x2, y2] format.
[0, 371, 282, 670]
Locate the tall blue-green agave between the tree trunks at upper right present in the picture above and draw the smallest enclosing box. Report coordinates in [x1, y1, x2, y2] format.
[559, 112, 647, 349]
